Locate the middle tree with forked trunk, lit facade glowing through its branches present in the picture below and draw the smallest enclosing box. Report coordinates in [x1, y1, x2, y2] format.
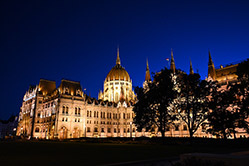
[171, 73, 216, 138]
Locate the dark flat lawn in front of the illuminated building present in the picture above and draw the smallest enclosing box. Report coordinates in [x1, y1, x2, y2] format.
[0, 138, 249, 166]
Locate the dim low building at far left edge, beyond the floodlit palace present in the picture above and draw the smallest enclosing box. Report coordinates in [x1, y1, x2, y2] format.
[0, 115, 18, 139]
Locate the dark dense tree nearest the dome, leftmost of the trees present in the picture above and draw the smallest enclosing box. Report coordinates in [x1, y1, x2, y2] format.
[133, 68, 176, 137]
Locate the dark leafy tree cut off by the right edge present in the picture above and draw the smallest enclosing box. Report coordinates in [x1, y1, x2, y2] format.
[208, 59, 249, 139]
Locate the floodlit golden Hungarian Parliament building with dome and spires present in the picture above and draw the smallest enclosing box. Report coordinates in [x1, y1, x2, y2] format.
[17, 49, 246, 139]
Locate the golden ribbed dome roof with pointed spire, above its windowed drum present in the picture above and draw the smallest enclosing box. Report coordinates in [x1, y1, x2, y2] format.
[106, 49, 130, 81]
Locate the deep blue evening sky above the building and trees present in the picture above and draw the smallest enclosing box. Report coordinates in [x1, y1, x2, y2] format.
[0, 0, 249, 119]
